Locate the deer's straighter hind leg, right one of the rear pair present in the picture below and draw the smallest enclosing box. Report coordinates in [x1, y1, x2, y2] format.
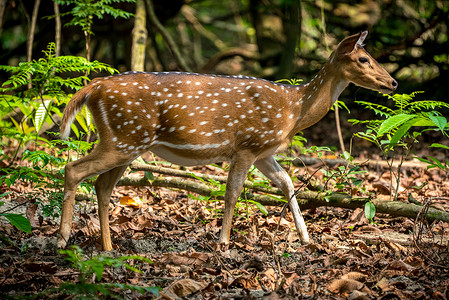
[95, 165, 128, 251]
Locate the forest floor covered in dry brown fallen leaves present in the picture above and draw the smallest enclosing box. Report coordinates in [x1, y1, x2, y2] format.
[0, 118, 449, 299]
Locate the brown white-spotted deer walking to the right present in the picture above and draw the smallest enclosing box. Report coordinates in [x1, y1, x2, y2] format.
[58, 31, 398, 250]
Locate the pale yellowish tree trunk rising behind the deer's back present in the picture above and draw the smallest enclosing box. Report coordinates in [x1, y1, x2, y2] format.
[131, 0, 148, 72]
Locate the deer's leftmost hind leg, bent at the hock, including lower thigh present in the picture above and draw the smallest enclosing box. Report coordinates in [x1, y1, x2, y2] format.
[58, 144, 132, 248]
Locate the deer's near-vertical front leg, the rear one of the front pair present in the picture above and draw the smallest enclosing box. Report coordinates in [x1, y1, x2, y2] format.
[219, 151, 254, 244]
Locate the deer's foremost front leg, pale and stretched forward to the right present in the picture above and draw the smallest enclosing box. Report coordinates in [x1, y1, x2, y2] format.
[254, 156, 310, 243]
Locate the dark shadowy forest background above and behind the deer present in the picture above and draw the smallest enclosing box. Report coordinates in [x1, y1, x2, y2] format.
[0, 0, 449, 148]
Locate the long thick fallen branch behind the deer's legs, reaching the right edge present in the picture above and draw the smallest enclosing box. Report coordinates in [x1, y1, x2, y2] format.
[117, 172, 449, 223]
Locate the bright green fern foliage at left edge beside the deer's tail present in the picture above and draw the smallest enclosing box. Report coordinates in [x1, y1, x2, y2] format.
[0, 43, 116, 142]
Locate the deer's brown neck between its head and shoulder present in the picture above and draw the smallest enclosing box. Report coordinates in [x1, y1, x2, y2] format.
[293, 58, 349, 133]
